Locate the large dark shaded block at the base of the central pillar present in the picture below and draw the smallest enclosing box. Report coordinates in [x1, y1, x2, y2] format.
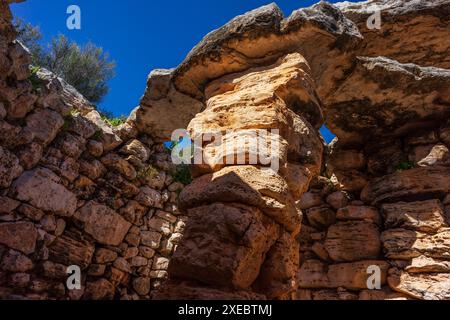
[169, 203, 278, 289]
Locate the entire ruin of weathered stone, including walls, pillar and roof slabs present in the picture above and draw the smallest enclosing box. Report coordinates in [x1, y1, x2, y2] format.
[0, 0, 450, 300]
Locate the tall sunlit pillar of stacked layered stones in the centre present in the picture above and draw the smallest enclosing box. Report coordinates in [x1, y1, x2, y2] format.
[162, 54, 322, 299]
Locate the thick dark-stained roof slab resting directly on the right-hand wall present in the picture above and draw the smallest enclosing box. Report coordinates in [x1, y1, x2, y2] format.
[324, 57, 450, 143]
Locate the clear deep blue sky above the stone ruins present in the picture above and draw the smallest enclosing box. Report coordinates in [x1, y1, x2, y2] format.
[12, 0, 337, 140]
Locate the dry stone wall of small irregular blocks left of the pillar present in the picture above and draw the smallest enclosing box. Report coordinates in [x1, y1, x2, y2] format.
[0, 1, 187, 299]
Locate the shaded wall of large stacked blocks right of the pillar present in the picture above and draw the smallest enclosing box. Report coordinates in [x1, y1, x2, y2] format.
[297, 123, 450, 300]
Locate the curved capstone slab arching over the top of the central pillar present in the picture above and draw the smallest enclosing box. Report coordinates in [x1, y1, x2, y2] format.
[137, 2, 362, 141]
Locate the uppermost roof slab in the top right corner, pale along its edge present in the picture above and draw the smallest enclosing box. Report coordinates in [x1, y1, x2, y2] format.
[335, 0, 450, 69]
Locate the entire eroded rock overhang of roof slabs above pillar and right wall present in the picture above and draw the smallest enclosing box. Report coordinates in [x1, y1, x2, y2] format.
[137, 0, 450, 148]
